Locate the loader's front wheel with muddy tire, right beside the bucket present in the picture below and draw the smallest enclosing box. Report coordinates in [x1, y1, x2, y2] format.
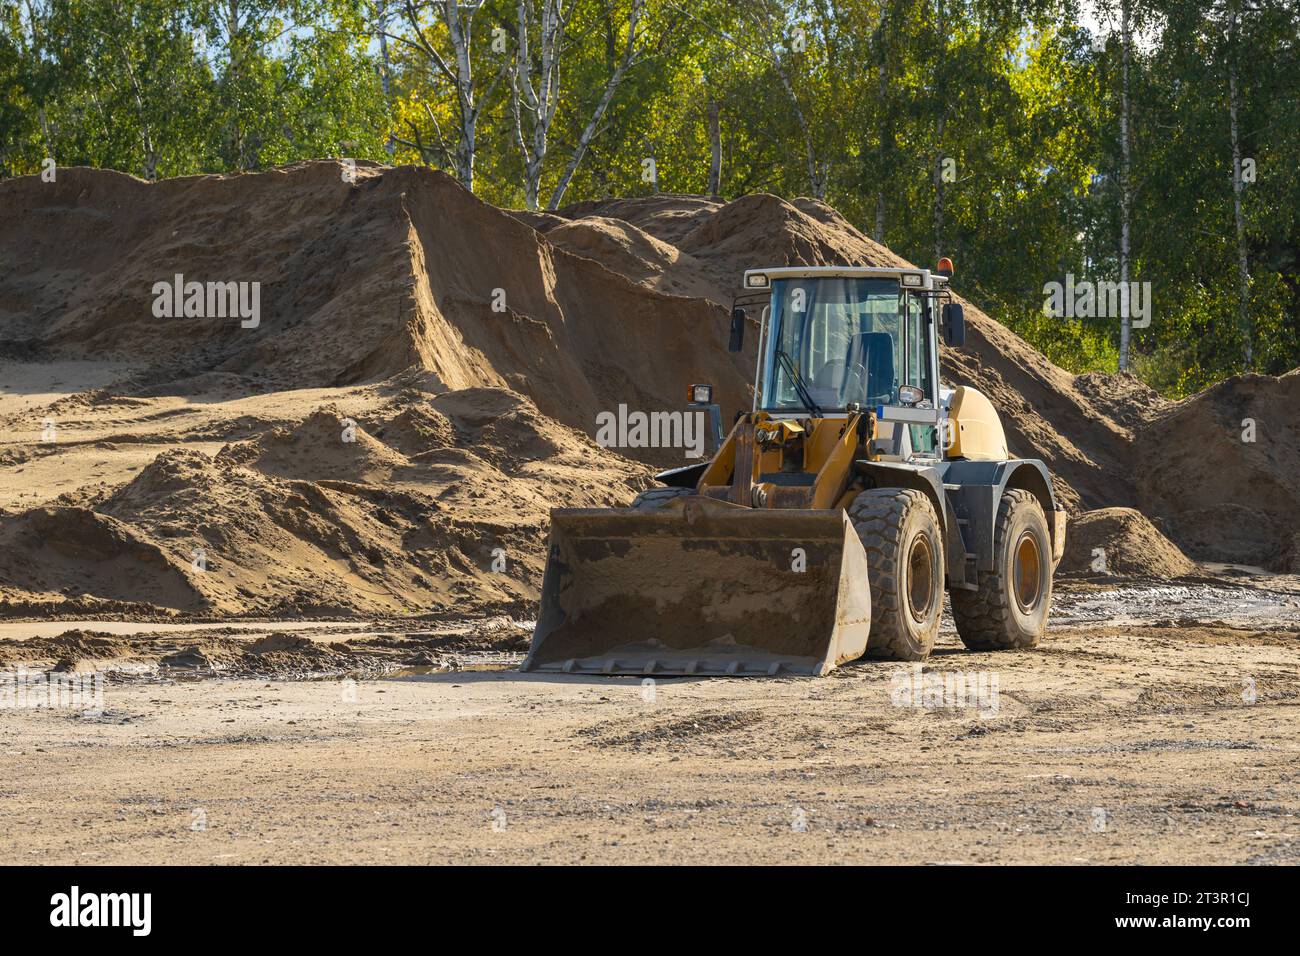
[849, 488, 944, 661]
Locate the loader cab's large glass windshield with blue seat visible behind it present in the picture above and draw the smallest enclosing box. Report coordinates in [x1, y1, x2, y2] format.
[763, 277, 933, 411]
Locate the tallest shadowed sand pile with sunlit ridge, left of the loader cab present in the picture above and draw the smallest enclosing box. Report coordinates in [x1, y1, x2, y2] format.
[0, 161, 748, 458]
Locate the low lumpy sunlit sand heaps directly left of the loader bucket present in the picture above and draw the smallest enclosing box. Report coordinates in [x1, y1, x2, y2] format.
[0, 389, 647, 617]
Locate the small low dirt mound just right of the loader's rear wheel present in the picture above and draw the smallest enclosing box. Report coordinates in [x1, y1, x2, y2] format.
[1058, 507, 1196, 578]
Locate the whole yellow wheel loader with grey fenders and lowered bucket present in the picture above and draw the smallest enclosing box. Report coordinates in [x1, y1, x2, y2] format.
[523, 259, 1066, 676]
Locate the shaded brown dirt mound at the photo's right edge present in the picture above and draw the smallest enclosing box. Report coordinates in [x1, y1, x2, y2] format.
[1136, 369, 1300, 570]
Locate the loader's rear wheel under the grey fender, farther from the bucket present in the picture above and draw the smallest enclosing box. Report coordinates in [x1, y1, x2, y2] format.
[949, 488, 1052, 650]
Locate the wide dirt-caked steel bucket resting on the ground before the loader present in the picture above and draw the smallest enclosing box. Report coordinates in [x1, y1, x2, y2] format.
[523, 497, 871, 676]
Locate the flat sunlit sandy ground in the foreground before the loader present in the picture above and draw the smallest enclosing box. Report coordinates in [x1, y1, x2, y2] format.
[0, 608, 1300, 865]
